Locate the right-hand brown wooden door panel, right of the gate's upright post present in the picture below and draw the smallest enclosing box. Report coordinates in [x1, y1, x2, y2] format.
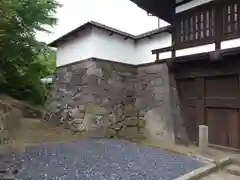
[204, 75, 240, 149]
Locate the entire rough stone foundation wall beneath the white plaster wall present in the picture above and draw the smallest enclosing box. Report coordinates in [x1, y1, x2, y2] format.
[46, 59, 187, 141]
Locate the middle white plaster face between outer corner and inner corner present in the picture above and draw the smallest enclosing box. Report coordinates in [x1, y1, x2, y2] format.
[91, 28, 137, 64]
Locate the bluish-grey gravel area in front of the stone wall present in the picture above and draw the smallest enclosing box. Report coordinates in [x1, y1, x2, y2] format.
[2, 139, 204, 180]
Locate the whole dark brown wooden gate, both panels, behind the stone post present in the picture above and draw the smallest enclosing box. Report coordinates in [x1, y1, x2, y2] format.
[177, 75, 240, 149]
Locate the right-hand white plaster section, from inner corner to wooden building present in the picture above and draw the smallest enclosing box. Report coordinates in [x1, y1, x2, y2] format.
[135, 32, 172, 64]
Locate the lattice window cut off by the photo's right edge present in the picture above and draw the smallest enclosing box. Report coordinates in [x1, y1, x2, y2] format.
[223, 2, 240, 35]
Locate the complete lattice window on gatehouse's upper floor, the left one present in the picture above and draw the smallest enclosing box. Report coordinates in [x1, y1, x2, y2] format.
[177, 6, 214, 44]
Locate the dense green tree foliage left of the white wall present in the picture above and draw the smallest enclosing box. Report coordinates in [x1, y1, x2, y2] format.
[0, 0, 59, 103]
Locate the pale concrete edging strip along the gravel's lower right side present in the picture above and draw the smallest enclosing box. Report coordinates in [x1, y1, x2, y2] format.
[175, 157, 232, 180]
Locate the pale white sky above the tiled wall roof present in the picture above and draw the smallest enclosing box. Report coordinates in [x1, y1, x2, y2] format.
[37, 0, 167, 43]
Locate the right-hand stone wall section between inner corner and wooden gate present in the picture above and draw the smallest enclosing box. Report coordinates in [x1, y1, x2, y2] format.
[136, 63, 174, 143]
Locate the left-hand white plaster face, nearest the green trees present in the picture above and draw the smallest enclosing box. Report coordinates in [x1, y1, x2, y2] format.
[56, 29, 92, 67]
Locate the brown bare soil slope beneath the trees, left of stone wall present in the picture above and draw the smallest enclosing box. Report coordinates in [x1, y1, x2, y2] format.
[0, 95, 82, 151]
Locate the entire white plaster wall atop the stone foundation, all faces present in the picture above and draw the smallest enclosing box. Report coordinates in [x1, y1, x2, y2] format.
[57, 25, 172, 67]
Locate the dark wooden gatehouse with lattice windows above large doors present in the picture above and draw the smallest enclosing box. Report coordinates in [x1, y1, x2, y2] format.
[132, 0, 240, 149]
